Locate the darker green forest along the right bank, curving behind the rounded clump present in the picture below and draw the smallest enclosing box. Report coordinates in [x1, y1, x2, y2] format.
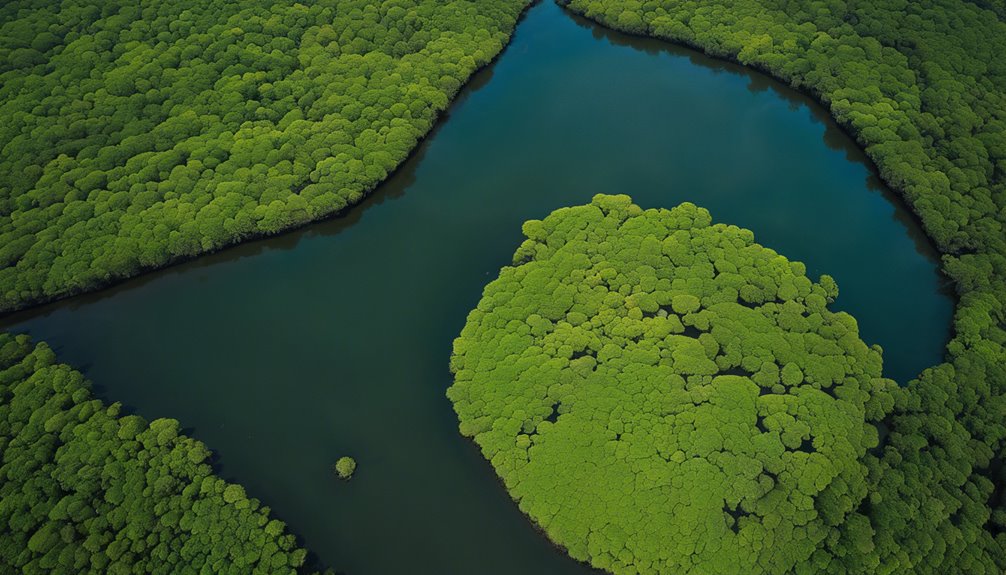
[568, 0, 1006, 575]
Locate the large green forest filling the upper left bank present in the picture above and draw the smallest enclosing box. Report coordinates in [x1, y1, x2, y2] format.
[0, 0, 527, 312]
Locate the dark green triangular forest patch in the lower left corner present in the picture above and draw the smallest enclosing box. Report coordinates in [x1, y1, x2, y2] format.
[0, 334, 317, 575]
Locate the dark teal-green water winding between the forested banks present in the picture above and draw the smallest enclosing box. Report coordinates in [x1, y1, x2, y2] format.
[4, 2, 953, 575]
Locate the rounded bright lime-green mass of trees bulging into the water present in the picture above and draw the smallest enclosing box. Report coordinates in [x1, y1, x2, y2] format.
[448, 195, 896, 575]
